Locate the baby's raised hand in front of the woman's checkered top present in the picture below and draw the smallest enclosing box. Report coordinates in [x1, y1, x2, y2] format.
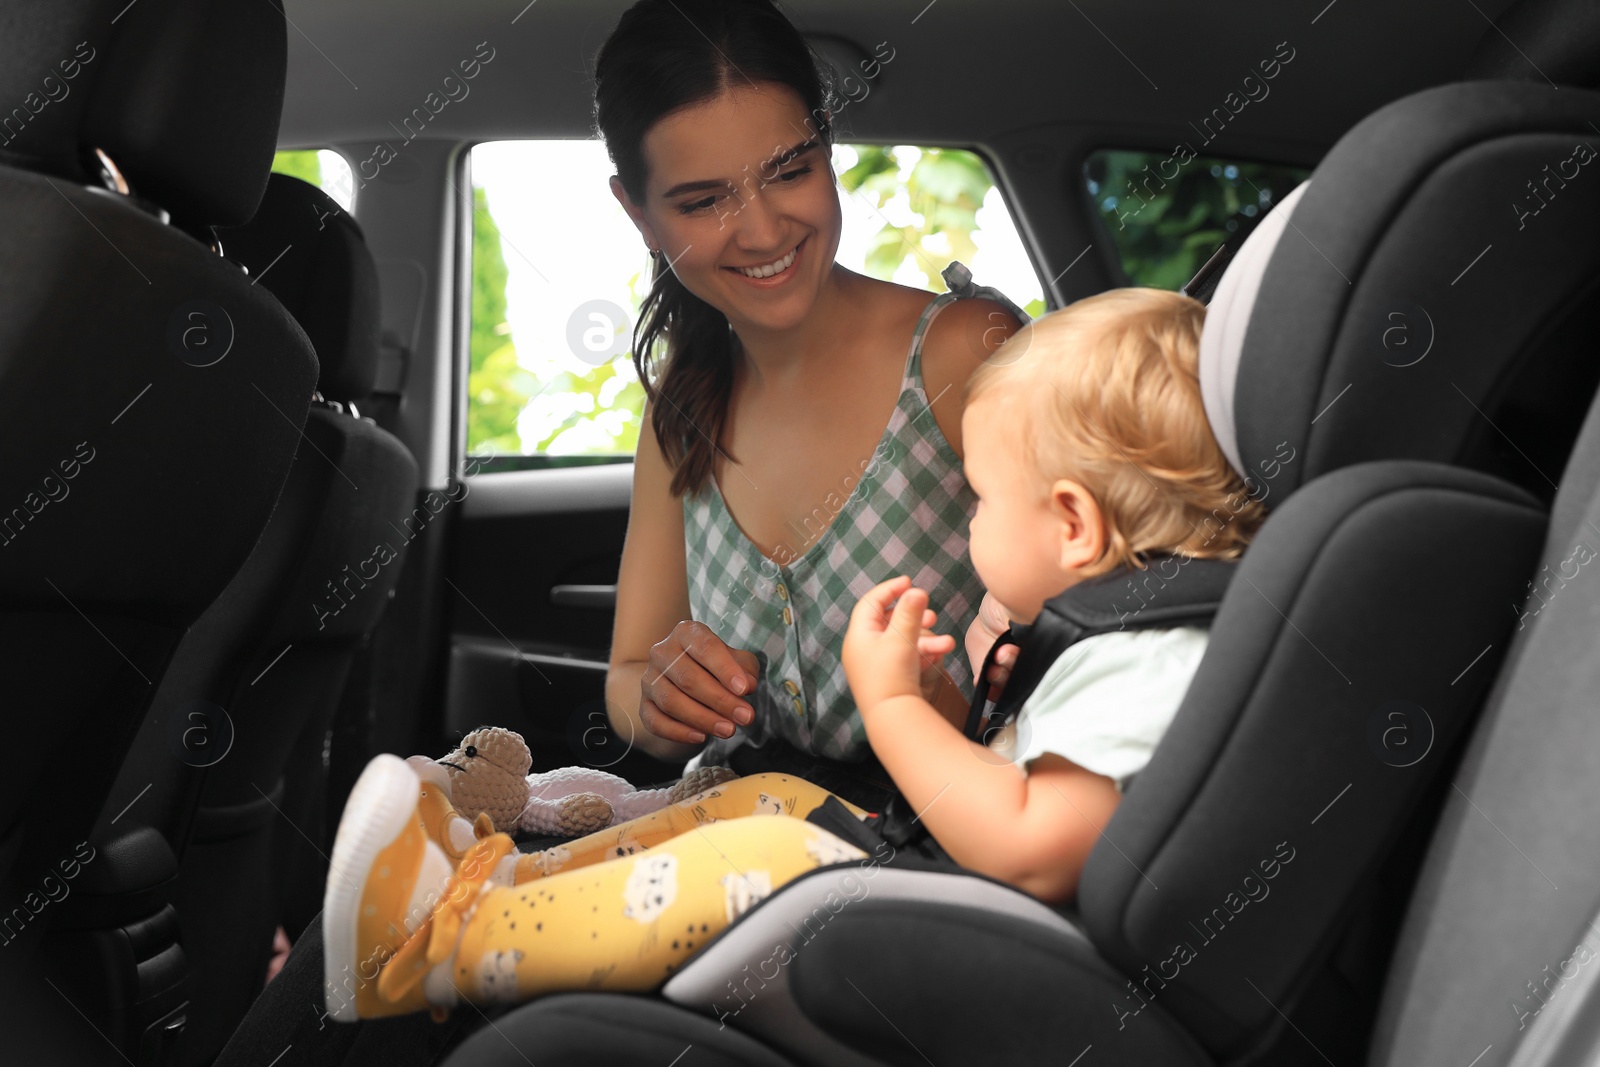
[840, 574, 955, 713]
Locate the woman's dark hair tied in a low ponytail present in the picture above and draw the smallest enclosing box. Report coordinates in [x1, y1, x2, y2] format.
[595, 0, 837, 496]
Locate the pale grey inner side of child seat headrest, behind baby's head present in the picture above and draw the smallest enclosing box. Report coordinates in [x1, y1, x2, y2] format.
[1200, 181, 1310, 480]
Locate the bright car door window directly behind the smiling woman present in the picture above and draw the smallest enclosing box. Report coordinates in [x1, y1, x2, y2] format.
[462, 141, 1045, 470]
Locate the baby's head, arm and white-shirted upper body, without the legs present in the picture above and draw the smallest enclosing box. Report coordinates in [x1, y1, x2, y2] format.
[843, 281, 1264, 902]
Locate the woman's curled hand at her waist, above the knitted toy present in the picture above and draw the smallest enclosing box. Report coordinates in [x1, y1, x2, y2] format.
[638, 619, 762, 744]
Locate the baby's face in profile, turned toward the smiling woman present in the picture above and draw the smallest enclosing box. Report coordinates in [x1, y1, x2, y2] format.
[962, 397, 1074, 622]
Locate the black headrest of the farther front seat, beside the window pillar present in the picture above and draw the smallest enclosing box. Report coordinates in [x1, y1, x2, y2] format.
[216, 174, 381, 402]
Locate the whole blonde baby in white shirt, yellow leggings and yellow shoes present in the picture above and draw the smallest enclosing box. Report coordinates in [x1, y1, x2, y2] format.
[323, 290, 1262, 1021]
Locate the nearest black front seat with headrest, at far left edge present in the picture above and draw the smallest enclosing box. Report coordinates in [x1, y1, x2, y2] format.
[0, 0, 317, 1062]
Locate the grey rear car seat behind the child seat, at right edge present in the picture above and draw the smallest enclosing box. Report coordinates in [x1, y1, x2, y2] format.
[1368, 0, 1600, 1067]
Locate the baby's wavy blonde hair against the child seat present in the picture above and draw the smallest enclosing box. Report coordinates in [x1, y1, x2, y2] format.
[966, 288, 1266, 577]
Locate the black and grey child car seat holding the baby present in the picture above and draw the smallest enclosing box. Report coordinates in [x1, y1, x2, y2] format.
[432, 83, 1600, 1065]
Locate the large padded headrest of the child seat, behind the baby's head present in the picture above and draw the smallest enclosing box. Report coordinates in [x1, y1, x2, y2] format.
[1198, 80, 1600, 509]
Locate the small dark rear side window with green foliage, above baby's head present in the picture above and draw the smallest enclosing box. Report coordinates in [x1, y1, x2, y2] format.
[1083, 146, 1310, 290]
